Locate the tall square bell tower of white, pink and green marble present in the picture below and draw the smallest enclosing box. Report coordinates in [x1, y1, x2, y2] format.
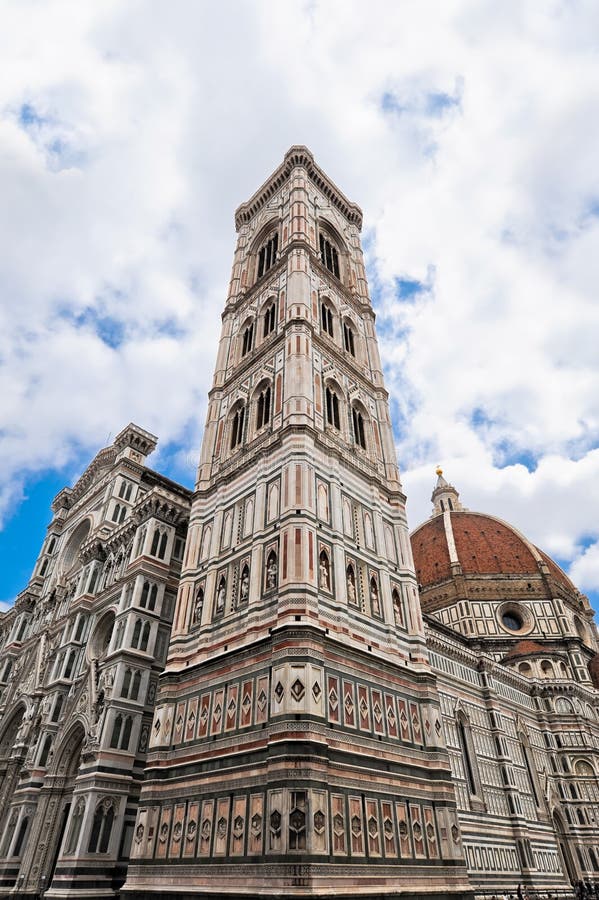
[124, 147, 469, 898]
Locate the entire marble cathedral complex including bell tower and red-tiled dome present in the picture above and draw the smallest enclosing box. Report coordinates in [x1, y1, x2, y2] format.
[0, 147, 599, 900]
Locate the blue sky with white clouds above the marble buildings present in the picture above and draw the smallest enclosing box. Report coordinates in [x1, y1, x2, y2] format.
[0, 0, 599, 608]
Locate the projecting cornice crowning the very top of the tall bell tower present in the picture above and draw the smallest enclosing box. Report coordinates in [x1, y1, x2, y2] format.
[235, 145, 362, 231]
